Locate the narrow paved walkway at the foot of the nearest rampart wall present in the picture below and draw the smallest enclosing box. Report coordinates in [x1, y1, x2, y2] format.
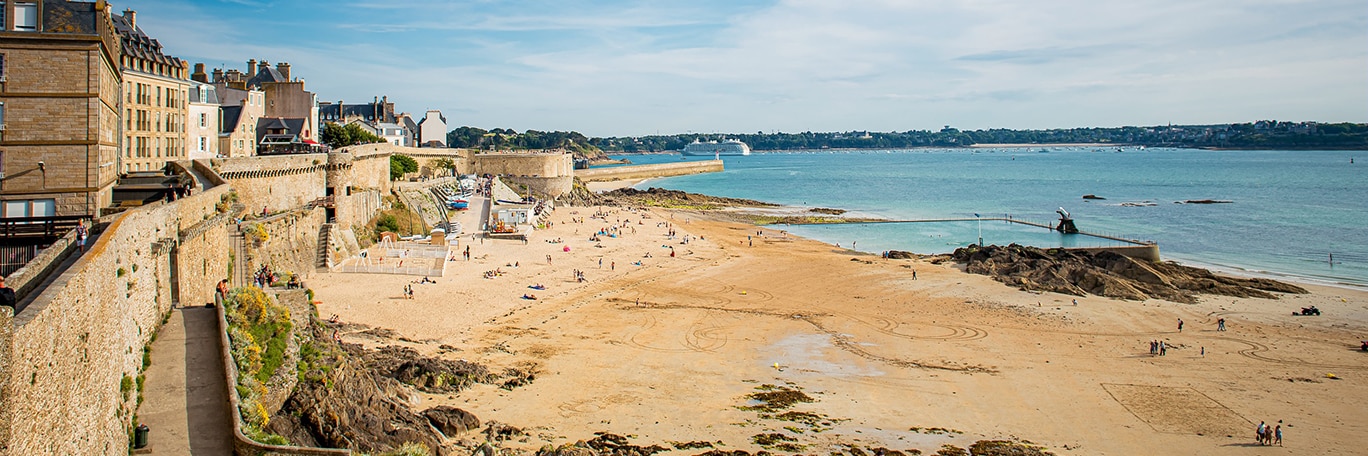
[138, 307, 233, 455]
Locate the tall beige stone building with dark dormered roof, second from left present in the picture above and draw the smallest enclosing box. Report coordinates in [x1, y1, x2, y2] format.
[114, 10, 190, 174]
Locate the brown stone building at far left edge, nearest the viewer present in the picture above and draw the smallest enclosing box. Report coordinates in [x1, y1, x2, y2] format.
[0, 0, 123, 220]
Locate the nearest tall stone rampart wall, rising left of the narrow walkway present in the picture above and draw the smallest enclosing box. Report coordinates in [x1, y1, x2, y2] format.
[0, 203, 186, 455]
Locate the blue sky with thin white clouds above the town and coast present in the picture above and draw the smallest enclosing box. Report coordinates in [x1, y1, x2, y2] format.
[111, 0, 1368, 137]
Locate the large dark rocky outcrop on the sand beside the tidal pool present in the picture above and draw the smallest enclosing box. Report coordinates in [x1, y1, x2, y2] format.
[951, 244, 1306, 303]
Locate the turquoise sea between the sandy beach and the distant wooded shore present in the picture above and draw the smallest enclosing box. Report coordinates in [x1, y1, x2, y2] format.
[613, 147, 1368, 288]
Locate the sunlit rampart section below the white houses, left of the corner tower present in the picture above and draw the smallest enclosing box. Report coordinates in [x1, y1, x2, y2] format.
[212, 153, 328, 214]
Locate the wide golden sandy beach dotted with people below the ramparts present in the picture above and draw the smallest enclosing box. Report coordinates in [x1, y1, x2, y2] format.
[309, 197, 1368, 455]
